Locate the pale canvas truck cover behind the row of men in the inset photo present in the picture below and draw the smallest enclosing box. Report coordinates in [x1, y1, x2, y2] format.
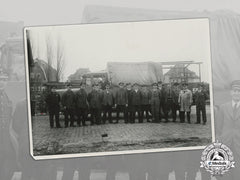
[107, 62, 163, 85]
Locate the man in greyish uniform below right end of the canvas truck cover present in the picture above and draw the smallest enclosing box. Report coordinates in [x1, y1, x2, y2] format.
[150, 83, 161, 123]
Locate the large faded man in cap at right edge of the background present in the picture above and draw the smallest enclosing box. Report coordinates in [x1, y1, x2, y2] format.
[215, 80, 240, 180]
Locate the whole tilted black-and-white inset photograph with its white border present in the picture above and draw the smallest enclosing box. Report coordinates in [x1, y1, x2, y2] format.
[24, 18, 215, 160]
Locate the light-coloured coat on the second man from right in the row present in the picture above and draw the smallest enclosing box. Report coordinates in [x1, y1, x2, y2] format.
[178, 89, 192, 112]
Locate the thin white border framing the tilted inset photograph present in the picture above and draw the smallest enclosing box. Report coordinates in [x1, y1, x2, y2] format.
[23, 17, 216, 160]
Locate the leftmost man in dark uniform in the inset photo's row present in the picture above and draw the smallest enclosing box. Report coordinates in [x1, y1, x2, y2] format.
[46, 87, 61, 128]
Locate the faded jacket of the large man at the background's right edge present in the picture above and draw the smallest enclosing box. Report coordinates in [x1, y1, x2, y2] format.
[216, 101, 240, 149]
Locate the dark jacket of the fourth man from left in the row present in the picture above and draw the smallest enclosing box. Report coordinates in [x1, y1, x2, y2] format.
[88, 90, 102, 109]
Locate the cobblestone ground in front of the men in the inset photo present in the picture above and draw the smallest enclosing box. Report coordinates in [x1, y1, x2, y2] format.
[32, 106, 211, 155]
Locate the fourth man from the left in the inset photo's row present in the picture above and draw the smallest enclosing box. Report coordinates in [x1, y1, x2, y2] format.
[88, 84, 102, 125]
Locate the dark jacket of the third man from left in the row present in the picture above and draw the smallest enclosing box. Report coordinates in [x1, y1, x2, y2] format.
[75, 89, 88, 109]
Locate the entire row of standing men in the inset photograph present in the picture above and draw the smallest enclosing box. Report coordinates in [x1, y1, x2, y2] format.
[46, 82, 208, 128]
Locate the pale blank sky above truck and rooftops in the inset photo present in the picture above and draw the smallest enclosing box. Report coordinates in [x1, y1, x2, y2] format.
[26, 19, 210, 82]
